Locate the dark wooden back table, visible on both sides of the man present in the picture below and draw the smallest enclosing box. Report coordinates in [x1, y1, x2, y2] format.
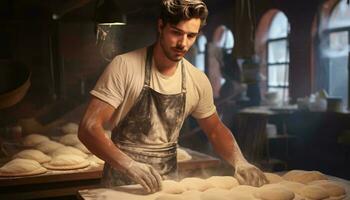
[0, 149, 220, 200]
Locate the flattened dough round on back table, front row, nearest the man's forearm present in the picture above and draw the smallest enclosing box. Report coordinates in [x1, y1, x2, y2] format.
[43, 154, 90, 170]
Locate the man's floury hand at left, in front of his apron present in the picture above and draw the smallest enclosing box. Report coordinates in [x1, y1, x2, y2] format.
[125, 160, 162, 193]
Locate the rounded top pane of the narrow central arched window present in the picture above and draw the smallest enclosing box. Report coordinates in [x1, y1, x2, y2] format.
[269, 12, 289, 39]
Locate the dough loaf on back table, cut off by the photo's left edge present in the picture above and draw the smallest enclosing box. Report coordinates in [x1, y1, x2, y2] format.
[0, 158, 47, 176]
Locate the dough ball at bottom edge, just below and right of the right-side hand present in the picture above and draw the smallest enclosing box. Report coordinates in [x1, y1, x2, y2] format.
[254, 184, 294, 200]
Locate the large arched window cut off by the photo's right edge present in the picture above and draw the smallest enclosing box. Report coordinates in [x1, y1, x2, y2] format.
[320, 0, 350, 106]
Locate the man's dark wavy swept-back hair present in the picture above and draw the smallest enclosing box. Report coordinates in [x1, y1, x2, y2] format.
[160, 0, 208, 28]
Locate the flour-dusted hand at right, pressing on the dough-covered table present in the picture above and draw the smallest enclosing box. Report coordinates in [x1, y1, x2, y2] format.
[234, 161, 268, 187]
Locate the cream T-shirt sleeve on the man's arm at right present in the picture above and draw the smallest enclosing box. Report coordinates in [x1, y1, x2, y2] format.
[192, 76, 216, 119]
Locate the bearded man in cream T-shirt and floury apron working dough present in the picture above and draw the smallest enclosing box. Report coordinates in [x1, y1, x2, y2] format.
[79, 0, 266, 195]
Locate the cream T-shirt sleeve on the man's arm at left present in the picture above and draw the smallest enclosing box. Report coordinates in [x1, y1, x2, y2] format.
[90, 56, 127, 108]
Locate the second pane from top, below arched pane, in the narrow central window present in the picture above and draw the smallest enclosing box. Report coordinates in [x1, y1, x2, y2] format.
[268, 40, 289, 63]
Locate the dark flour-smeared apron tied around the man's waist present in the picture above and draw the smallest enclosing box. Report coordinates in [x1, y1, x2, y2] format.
[102, 46, 186, 187]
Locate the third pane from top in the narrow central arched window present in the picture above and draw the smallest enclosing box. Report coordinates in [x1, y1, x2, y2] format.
[268, 65, 289, 86]
